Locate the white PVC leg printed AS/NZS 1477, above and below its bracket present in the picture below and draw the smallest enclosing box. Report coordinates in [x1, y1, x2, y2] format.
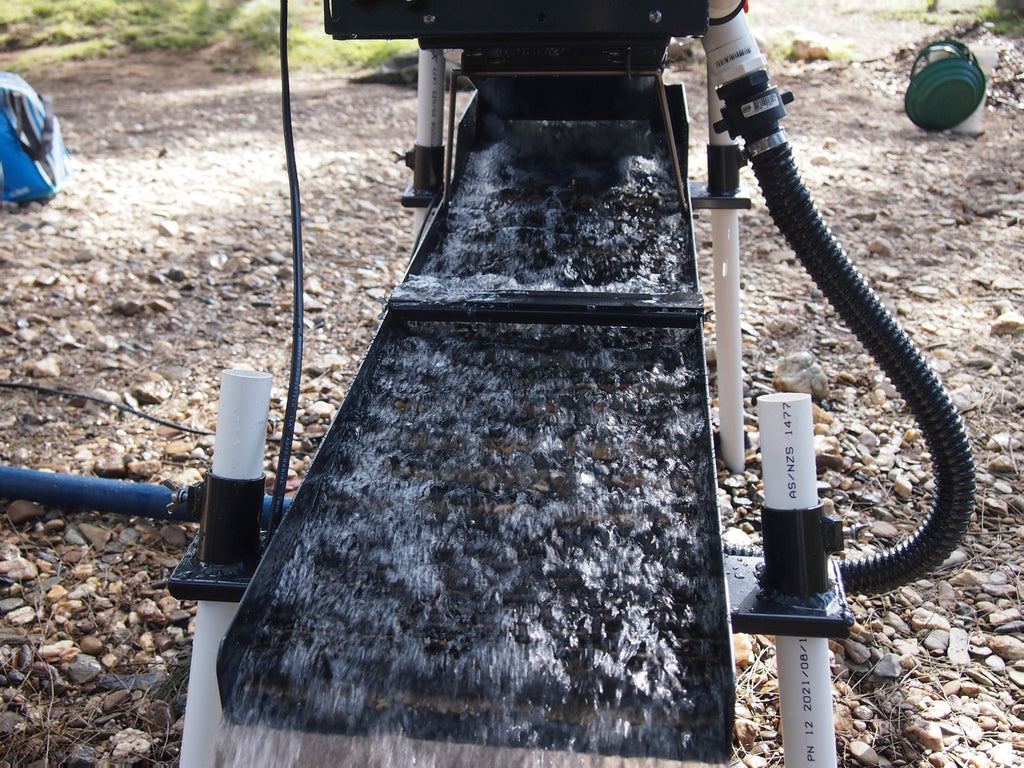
[758, 392, 837, 768]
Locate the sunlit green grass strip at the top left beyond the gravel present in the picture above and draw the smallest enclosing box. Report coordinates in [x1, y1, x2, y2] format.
[0, 0, 416, 71]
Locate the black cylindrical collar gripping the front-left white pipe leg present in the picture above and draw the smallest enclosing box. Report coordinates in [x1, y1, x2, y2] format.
[197, 472, 264, 565]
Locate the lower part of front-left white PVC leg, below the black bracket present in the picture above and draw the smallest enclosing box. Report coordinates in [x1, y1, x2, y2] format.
[180, 600, 238, 768]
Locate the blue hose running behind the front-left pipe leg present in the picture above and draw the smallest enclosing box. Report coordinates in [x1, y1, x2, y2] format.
[0, 466, 291, 525]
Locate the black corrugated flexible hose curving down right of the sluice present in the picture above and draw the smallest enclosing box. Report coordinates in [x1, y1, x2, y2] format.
[751, 142, 975, 593]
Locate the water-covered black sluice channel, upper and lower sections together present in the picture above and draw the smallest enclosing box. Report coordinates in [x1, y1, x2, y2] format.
[218, 73, 733, 768]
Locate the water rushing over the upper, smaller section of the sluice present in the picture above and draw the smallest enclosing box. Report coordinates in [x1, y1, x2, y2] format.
[404, 115, 695, 293]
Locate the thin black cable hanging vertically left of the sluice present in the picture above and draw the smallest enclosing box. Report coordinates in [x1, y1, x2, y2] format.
[267, 0, 304, 541]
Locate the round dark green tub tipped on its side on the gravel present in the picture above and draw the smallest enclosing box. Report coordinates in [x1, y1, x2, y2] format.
[903, 40, 985, 131]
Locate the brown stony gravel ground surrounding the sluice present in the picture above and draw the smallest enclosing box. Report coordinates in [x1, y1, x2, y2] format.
[0, 6, 1024, 768]
